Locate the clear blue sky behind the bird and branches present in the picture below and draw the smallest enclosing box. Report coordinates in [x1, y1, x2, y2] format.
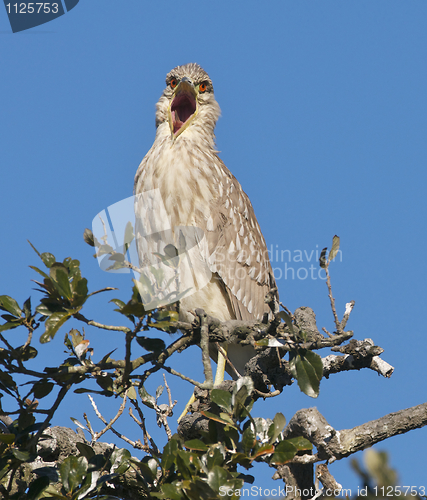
[0, 0, 427, 488]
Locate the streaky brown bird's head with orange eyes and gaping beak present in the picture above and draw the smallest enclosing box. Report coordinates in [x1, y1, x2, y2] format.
[156, 63, 221, 141]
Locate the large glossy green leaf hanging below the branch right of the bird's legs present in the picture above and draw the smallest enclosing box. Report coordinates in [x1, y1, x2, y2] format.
[289, 349, 323, 398]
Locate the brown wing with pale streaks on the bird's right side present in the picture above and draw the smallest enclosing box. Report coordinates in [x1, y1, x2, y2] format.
[205, 157, 276, 320]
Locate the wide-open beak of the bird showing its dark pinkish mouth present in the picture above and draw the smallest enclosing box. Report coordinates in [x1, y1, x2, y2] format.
[168, 77, 199, 139]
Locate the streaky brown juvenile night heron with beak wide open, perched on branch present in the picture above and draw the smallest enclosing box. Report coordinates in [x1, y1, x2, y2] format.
[135, 63, 276, 384]
